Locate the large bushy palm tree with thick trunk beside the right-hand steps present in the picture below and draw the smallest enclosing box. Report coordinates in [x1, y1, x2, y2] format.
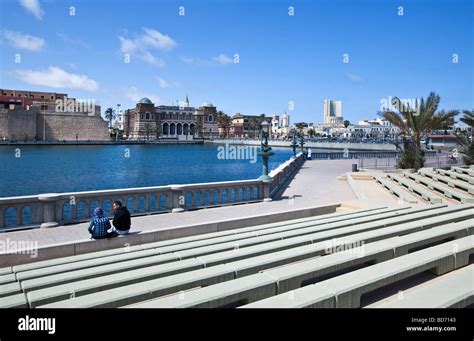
[380, 92, 458, 170]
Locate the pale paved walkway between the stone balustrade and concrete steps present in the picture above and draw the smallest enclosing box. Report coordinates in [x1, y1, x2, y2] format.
[0, 160, 397, 247]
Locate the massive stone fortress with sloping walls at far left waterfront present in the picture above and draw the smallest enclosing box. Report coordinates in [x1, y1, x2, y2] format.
[0, 89, 110, 141]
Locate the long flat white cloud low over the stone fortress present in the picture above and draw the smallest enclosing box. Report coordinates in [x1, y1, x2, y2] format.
[15, 66, 99, 91]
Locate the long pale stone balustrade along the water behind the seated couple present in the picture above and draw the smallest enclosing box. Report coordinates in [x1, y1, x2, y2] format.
[0, 154, 304, 231]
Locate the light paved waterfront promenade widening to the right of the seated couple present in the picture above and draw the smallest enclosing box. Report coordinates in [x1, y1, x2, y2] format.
[0, 160, 397, 265]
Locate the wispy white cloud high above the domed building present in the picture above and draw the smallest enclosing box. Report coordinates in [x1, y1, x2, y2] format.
[118, 28, 176, 67]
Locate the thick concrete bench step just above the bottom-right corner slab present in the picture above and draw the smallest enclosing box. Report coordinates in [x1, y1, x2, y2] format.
[244, 236, 474, 308]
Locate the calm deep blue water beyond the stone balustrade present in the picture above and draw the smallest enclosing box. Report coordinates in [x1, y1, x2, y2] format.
[0, 145, 300, 197]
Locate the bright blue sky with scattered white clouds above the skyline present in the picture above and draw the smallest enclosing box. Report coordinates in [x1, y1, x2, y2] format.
[0, 0, 474, 123]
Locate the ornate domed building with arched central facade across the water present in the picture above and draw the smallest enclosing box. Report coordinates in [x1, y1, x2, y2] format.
[124, 95, 218, 140]
